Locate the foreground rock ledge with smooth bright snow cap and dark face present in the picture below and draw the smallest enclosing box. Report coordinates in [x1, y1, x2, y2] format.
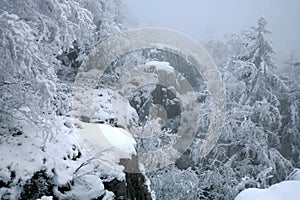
[78, 121, 151, 200]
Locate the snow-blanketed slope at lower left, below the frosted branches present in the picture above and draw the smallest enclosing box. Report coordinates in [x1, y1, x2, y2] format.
[0, 117, 136, 199]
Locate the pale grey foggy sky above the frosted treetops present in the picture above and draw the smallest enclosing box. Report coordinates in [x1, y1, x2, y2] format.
[123, 0, 300, 63]
